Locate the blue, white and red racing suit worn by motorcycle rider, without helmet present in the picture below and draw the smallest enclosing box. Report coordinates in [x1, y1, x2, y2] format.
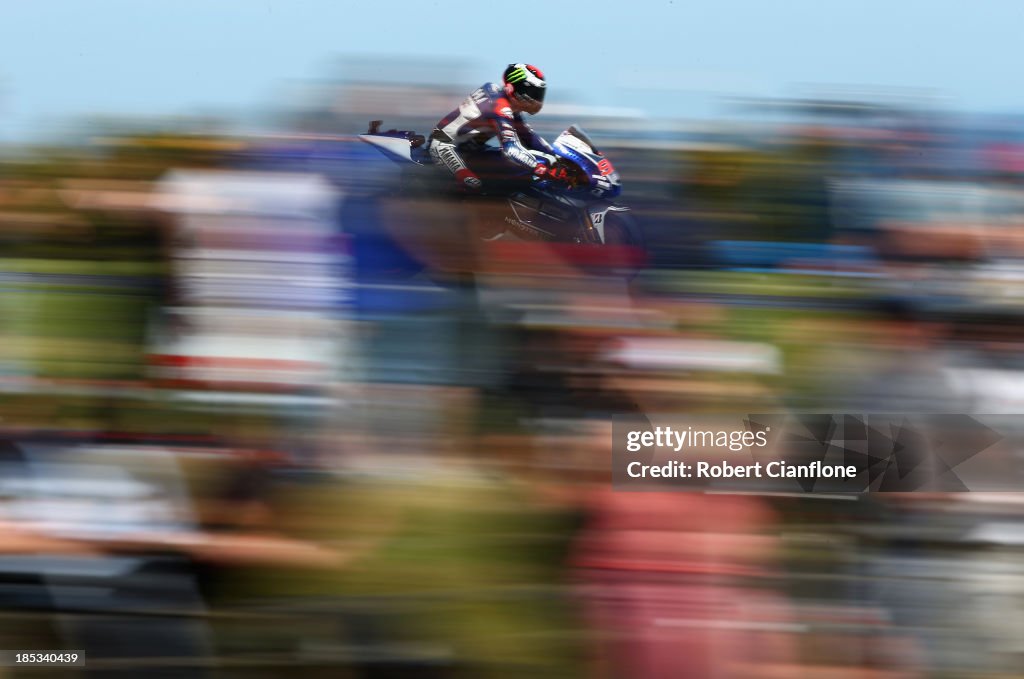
[427, 83, 558, 192]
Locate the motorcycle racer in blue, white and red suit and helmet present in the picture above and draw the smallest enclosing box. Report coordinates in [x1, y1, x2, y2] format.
[427, 63, 567, 193]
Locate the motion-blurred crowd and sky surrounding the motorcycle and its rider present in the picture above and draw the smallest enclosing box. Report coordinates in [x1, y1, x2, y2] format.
[0, 0, 1024, 679]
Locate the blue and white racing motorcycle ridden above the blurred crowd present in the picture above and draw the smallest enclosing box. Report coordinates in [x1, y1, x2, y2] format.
[359, 121, 644, 260]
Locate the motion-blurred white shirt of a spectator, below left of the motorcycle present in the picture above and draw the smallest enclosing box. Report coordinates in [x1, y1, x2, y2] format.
[150, 171, 346, 391]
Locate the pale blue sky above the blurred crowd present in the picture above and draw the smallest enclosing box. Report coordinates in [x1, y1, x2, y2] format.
[0, 0, 1024, 140]
